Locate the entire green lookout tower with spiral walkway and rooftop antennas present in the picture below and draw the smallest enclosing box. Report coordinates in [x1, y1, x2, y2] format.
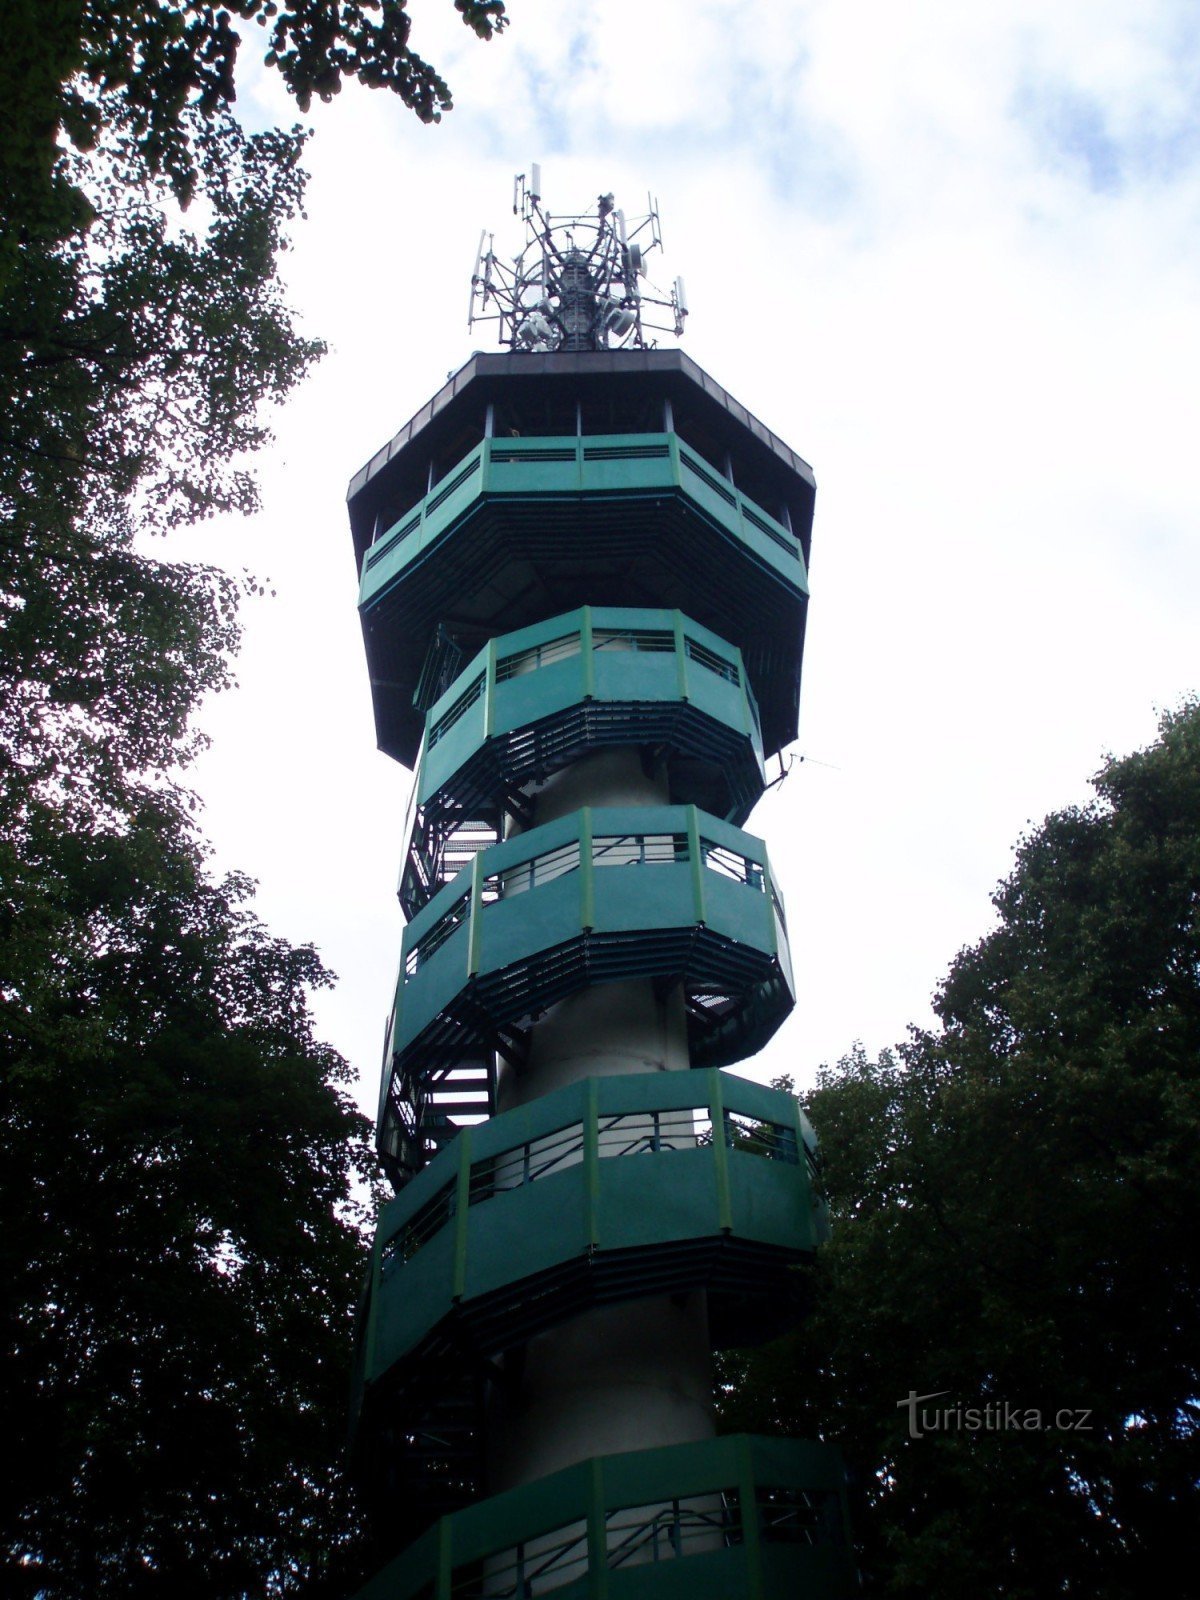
[349, 166, 853, 1600]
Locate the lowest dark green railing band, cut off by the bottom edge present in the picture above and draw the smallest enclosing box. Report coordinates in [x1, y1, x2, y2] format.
[358, 1434, 856, 1600]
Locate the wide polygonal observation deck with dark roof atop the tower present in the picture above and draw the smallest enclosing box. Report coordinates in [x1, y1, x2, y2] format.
[350, 350, 813, 765]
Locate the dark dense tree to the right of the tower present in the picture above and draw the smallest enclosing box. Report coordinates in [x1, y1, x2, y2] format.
[728, 704, 1200, 1600]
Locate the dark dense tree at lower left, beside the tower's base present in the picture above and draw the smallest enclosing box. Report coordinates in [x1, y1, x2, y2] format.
[0, 797, 380, 1600]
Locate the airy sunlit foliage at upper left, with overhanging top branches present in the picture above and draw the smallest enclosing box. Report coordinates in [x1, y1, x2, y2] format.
[0, 0, 504, 810]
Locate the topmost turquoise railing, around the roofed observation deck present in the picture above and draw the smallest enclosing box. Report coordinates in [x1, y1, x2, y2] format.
[360, 434, 808, 606]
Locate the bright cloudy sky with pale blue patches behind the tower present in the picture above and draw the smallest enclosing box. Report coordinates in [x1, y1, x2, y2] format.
[176, 0, 1200, 1109]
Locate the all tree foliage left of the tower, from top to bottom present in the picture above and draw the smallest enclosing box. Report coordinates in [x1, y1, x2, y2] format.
[0, 0, 504, 1600]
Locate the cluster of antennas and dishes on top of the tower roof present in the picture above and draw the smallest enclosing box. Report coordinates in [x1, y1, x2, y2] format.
[467, 162, 688, 354]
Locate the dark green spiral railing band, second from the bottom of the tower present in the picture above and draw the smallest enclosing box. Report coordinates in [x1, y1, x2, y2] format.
[360, 1069, 829, 1401]
